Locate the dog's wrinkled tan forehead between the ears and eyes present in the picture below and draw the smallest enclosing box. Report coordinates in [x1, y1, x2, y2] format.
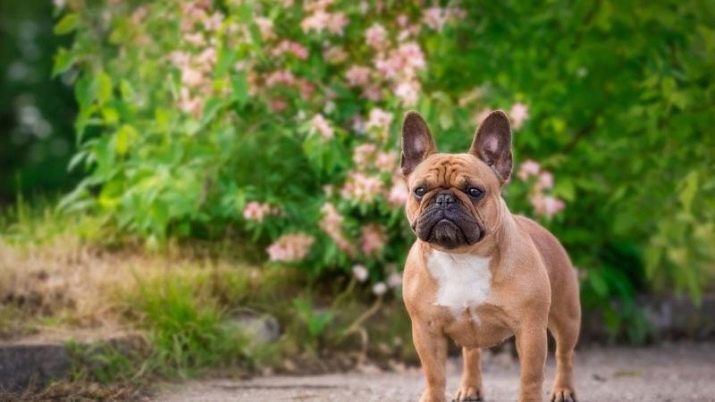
[410, 154, 497, 187]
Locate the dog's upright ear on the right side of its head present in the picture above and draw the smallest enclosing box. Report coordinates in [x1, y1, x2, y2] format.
[469, 110, 513, 183]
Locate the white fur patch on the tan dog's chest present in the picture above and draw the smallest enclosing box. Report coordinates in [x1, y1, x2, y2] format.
[427, 250, 492, 317]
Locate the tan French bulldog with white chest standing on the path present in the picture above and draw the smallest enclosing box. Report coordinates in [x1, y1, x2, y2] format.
[400, 111, 581, 402]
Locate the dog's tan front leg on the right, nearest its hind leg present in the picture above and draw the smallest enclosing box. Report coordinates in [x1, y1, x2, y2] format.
[516, 324, 547, 402]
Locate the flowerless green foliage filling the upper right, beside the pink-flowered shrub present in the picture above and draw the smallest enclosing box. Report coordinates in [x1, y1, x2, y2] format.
[442, 1, 715, 326]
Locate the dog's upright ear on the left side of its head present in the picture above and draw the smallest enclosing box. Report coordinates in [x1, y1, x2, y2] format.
[400, 112, 437, 177]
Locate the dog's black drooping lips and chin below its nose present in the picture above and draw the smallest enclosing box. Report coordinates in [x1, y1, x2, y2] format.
[415, 210, 484, 249]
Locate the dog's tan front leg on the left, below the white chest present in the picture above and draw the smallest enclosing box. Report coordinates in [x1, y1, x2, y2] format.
[412, 321, 447, 402]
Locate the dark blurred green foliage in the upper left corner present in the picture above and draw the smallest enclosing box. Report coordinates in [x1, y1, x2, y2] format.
[0, 0, 77, 203]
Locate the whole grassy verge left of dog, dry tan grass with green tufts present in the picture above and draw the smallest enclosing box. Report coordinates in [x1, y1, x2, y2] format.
[0, 207, 411, 400]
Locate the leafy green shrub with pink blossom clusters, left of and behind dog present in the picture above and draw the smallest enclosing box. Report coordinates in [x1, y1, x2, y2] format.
[57, 0, 564, 293]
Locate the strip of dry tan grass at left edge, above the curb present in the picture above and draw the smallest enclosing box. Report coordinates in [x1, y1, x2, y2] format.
[0, 231, 268, 340]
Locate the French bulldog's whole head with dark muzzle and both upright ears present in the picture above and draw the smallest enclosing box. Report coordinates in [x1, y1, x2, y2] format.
[401, 111, 512, 250]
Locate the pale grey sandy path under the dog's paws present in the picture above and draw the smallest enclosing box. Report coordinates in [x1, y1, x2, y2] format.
[155, 343, 715, 402]
